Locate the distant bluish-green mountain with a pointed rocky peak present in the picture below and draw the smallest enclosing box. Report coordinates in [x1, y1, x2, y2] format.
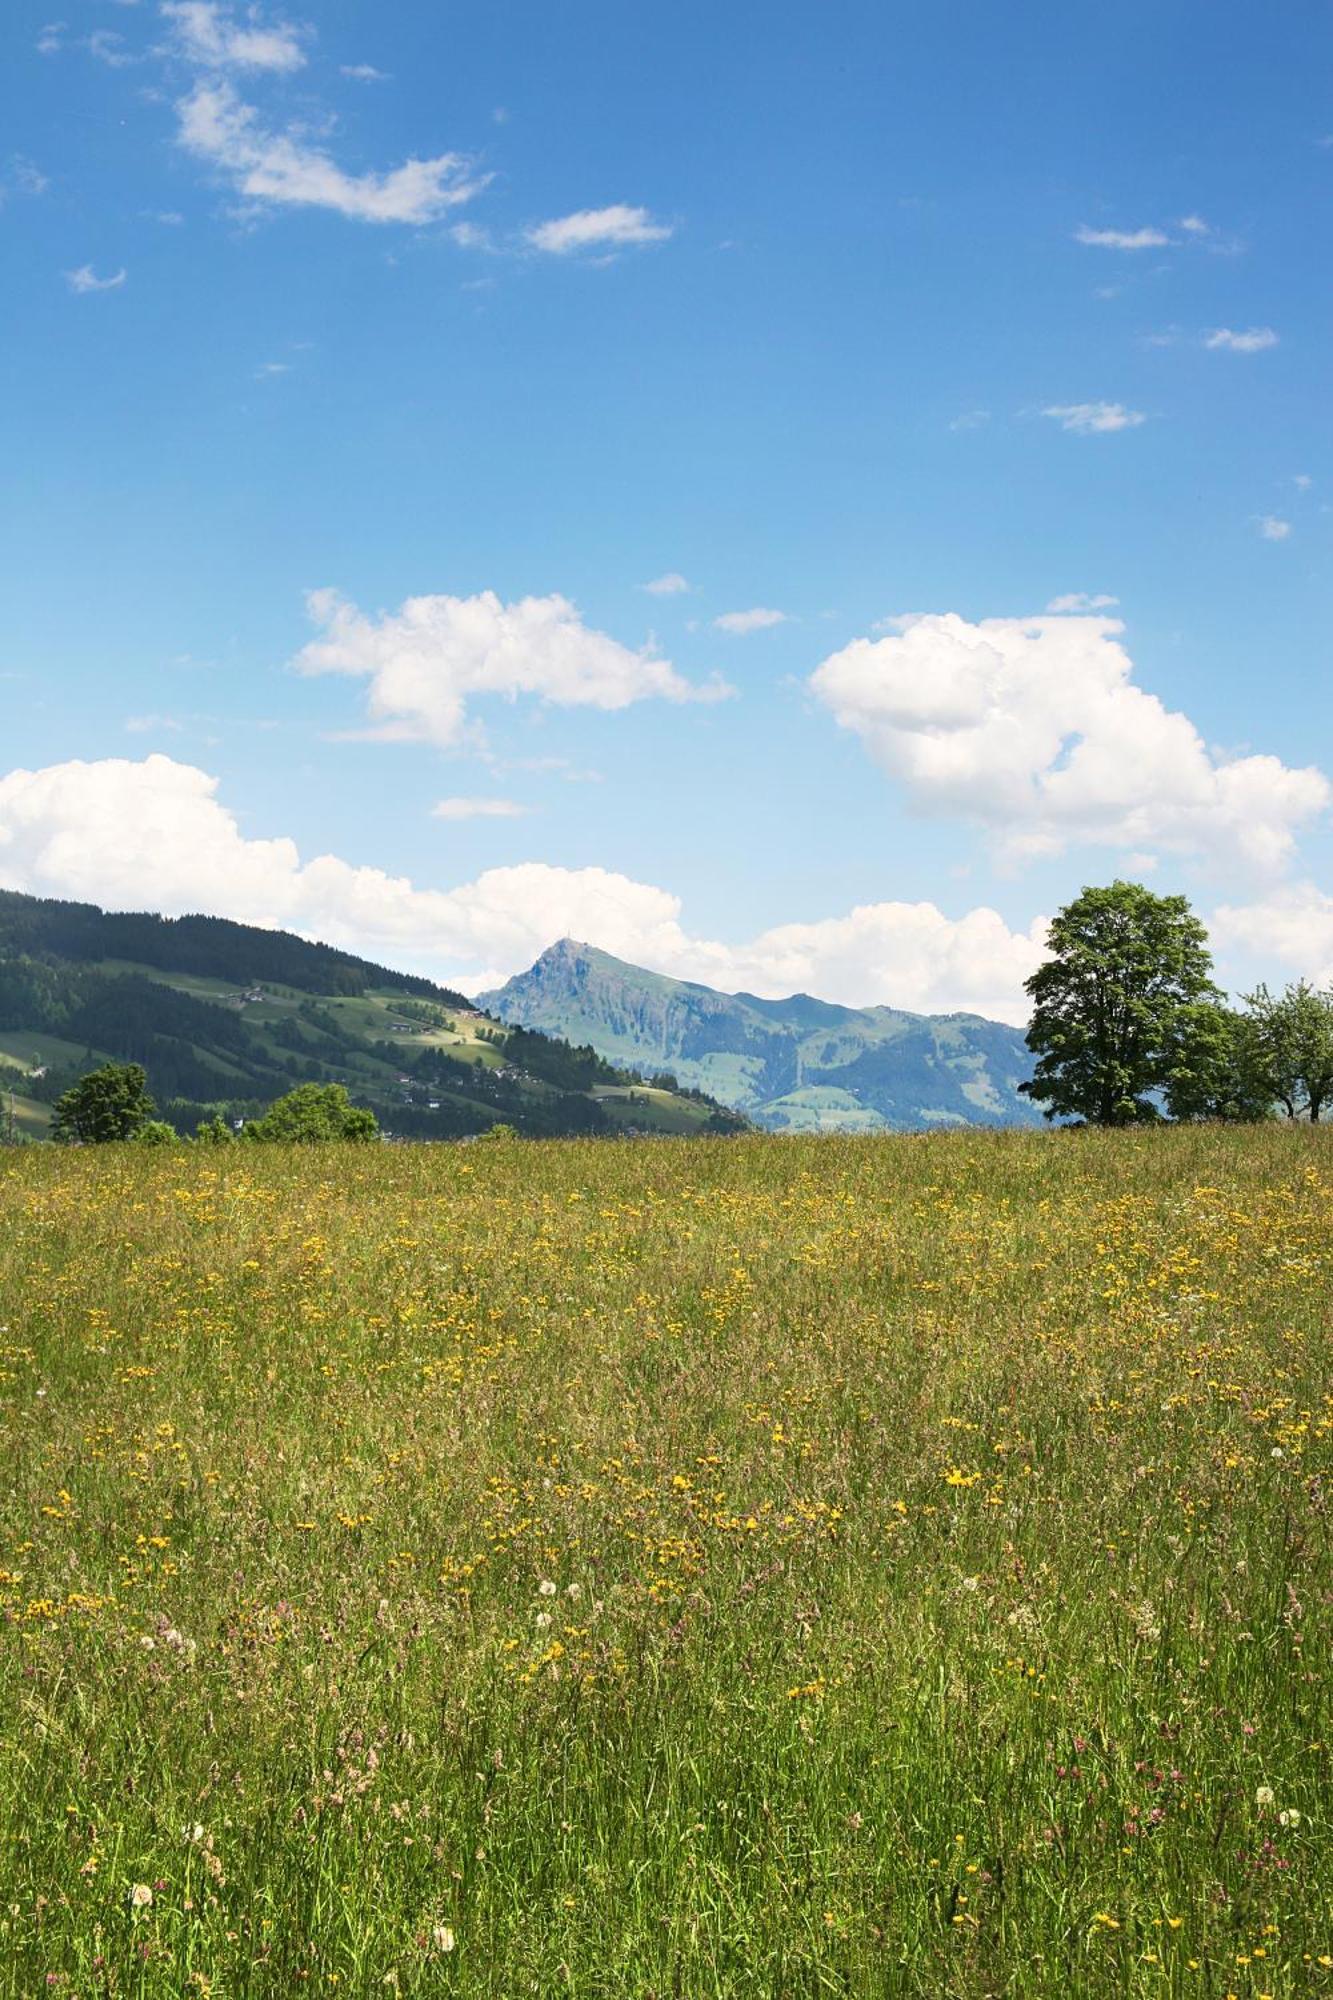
[478, 938, 1041, 1132]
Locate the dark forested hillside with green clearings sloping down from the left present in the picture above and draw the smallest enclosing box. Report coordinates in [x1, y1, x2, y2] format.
[0, 890, 745, 1138]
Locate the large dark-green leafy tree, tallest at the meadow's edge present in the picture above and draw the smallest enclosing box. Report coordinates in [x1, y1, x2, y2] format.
[1021, 882, 1221, 1126]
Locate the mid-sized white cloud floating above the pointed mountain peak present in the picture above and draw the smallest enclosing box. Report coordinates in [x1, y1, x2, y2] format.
[296, 590, 731, 746]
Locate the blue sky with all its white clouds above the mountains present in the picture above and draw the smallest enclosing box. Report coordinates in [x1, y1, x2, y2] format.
[0, 0, 1333, 1018]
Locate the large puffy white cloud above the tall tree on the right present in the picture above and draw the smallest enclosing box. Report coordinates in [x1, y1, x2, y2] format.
[811, 612, 1333, 872]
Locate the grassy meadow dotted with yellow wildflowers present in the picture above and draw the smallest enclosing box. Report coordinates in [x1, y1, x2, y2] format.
[0, 1128, 1333, 2000]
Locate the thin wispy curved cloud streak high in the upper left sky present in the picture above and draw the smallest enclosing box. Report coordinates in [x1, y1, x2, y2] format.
[176, 82, 488, 222]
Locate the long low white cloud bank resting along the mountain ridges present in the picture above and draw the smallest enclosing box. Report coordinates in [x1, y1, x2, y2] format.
[0, 756, 1045, 1020]
